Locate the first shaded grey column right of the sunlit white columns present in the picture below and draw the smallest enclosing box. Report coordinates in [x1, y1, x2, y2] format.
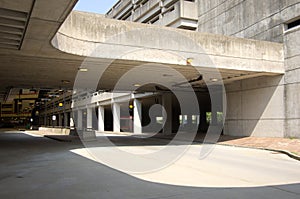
[162, 93, 172, 135]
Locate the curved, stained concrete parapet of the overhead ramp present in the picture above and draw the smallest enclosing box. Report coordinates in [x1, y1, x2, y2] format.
[52, 11, 284, 87]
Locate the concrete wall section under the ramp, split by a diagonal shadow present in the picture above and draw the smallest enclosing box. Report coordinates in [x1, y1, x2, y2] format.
[224, 76, 285, 137]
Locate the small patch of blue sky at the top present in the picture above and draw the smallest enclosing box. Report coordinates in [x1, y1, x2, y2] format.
[74, 0, 118, 14]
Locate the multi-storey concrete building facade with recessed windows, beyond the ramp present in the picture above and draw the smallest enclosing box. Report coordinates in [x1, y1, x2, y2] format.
[106, 0, 198, 30]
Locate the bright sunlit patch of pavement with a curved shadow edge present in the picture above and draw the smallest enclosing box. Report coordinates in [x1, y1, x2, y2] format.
[72, 145, 300, 187]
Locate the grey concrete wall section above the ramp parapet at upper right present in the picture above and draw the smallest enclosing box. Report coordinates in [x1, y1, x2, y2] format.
[198, 0, 300, 42]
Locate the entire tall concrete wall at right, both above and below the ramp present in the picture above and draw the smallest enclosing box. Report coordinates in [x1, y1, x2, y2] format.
[198, 0, 300, 137]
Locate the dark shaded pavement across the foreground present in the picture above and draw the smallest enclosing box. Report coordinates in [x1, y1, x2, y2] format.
[0, 132, 300, 199]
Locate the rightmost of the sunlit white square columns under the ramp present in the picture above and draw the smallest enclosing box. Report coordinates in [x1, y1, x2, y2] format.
[133, 99, 142, 134]
